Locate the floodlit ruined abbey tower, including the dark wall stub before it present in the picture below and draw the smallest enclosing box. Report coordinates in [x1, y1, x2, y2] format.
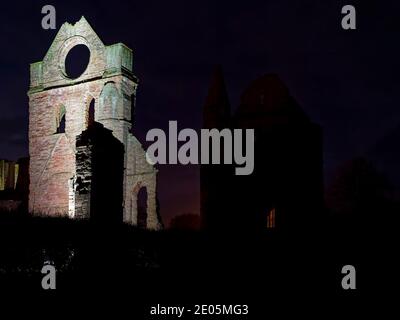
[28, 17, 161, 229]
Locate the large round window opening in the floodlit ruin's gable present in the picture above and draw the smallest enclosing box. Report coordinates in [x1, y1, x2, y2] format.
[65, 44, 90, 79]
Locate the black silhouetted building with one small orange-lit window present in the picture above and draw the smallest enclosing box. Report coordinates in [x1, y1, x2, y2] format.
[201, 75, 323, 230]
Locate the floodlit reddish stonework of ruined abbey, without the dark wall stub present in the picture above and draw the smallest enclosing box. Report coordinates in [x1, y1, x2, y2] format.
[28, 17, 161, 229]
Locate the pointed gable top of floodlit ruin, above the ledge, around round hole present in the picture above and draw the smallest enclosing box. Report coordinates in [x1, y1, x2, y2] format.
[28, 17, 137, 94]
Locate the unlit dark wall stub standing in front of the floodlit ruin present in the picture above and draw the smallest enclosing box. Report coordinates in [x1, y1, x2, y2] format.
[75, 122, 124, 222]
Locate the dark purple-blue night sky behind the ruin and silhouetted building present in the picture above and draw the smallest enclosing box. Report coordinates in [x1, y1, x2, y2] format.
[0, 0, 400, 222]
